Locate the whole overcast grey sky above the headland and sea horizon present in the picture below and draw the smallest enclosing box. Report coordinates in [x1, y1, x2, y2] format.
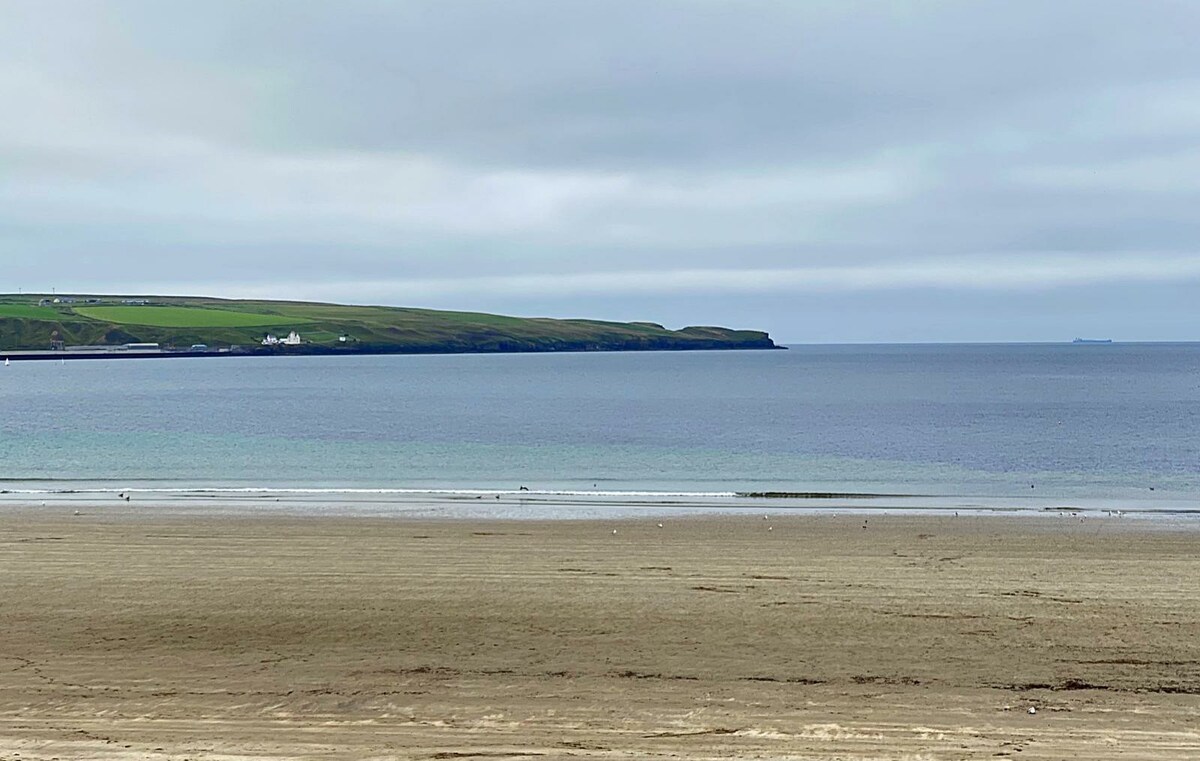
[0, 0, 1200, 343]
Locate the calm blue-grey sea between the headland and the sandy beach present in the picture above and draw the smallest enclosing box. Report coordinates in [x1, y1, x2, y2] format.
[0, 343, 1200, 520]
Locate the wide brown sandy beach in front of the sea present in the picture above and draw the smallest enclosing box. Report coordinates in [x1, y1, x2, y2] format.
[0, 510, 1200, 760]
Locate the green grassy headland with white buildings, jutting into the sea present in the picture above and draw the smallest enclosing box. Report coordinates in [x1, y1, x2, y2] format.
[0, 294, 779, 354]
